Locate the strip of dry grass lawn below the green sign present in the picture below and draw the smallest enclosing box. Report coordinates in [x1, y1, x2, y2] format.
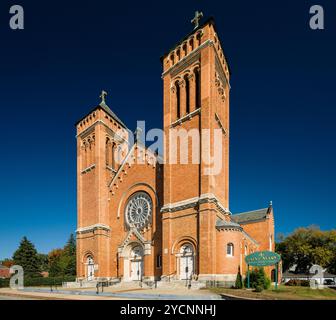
[210, 285, 336, 300]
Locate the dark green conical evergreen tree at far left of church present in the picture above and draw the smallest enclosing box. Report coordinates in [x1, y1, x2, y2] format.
[13, 237, 40, 277]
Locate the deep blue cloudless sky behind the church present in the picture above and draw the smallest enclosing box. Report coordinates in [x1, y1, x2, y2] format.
[0, 0, 336, 259]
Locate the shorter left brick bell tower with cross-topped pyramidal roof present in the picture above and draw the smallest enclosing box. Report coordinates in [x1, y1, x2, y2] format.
[76, 91, 128, 279]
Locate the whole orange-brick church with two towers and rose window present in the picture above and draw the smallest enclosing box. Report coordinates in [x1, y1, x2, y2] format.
[76, 12, 275, 285]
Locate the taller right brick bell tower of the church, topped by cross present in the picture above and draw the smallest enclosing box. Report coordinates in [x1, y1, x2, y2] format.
[161, 12, 230, 280]
